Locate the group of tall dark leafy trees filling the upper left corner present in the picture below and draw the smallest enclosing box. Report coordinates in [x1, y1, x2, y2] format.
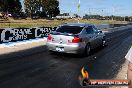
[0, 0, 60, 18]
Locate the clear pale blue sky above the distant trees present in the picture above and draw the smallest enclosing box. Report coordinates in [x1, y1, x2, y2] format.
[21, 0, 132, 16]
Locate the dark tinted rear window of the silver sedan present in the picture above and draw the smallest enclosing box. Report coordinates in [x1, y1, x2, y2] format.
[56, 26, 83, 34]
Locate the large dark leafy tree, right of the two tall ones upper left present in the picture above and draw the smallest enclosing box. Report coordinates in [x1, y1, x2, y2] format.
[24, 0, 60, 17]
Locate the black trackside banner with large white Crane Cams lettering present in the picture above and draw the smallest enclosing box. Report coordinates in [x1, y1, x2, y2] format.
[0, 27, 57, 43]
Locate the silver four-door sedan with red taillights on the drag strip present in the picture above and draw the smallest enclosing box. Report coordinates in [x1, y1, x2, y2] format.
[47, 23, 106, 55]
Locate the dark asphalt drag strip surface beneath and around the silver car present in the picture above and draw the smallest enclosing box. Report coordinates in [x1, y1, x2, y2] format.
[0, 29, 132, 88]
